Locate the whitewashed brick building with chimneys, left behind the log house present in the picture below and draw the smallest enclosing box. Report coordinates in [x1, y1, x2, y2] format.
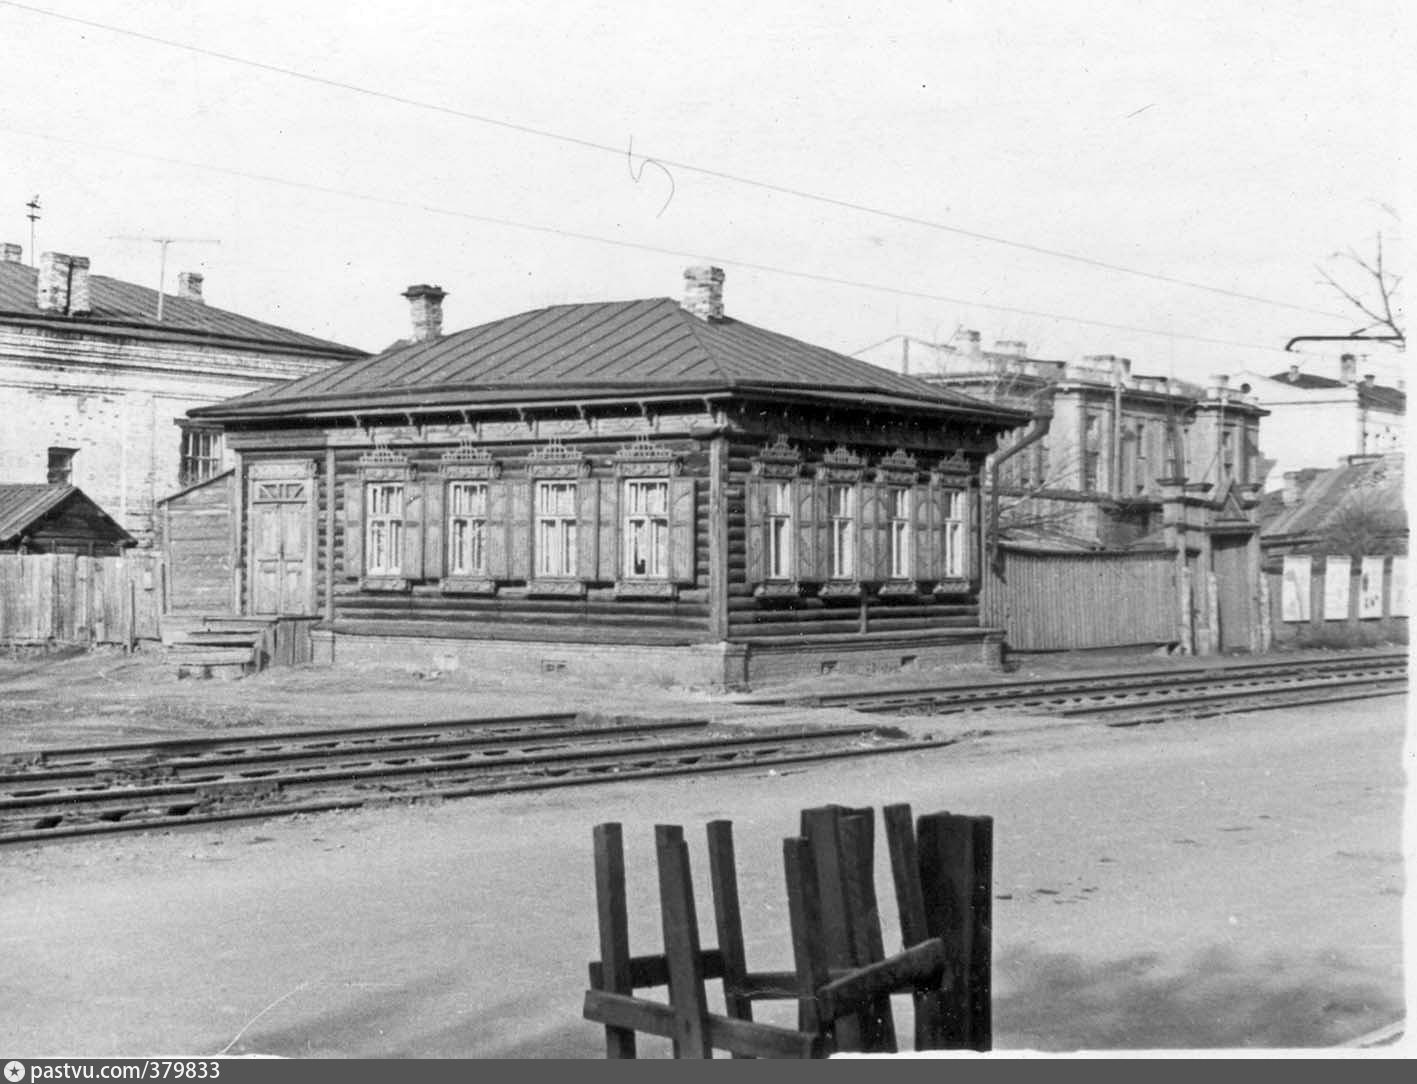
[0, 244, 364, 544]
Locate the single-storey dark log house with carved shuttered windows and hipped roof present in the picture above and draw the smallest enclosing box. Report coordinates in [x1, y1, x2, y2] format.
[185, 268, 1027, 687]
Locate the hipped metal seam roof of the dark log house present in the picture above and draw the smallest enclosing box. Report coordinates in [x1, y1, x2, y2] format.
[191, 298, 1026, 427]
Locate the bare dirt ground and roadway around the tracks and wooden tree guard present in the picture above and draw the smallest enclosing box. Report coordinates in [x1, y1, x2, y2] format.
[0, 643, 1413, 1057]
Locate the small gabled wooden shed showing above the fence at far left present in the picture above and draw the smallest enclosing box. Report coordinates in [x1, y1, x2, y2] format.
[0, 483, 137, 557]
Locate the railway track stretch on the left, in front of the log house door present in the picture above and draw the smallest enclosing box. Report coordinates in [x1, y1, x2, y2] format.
[0, 716, 948, 843]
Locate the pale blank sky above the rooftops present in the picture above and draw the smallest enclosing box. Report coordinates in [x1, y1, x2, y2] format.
[0, 0, 1414, 383]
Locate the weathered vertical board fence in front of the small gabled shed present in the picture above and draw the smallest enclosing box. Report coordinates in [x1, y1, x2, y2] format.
[0, 551, 164, 646]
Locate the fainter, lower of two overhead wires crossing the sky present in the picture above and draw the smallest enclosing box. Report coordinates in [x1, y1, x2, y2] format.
[0, 126, 1314, 354]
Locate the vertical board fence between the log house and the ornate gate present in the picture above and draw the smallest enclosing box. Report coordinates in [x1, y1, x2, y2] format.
[981, 548, 1180, 650]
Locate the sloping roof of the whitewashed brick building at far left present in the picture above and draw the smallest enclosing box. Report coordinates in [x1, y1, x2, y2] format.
[0, 261, 367, 358]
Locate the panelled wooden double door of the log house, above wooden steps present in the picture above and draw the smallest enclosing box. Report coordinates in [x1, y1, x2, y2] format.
[247, 461, 316, 616]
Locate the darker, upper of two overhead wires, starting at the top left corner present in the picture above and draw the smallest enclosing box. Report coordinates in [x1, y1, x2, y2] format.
[0, 0, 1345, 319]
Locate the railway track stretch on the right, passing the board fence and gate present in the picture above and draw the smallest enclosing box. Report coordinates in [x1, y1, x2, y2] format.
[748, 653, 1407, 726]
